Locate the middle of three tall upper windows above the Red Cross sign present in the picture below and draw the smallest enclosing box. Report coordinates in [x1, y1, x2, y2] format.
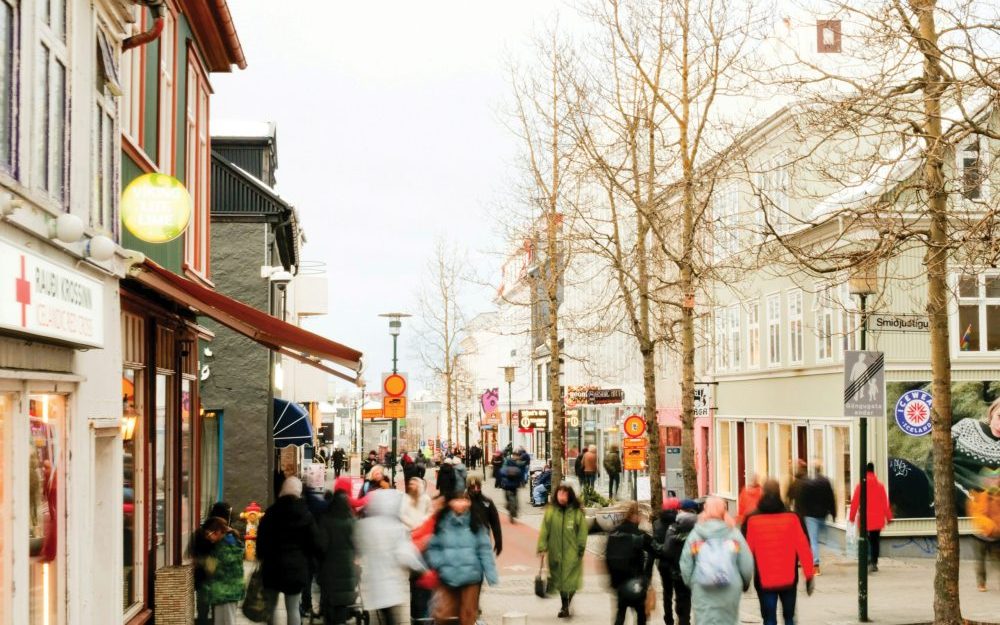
[31, 0, 69, 205]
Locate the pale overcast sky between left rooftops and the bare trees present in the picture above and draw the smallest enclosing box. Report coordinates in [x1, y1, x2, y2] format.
[212, 0, 576, 394]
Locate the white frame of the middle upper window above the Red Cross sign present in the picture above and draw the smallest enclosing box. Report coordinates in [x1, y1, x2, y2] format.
[29, 0, 73, 208]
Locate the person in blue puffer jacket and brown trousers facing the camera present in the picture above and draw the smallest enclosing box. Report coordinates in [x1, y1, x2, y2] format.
[424, 493, 500, 625]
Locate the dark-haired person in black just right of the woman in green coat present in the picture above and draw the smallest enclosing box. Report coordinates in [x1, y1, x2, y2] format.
[604, 501, 653, 625]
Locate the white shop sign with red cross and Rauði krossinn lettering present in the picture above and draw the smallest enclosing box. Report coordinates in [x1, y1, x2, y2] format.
[0, 241, 104, 347]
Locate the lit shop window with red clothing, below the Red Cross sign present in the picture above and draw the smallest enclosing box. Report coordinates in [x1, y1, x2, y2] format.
[26, 395, 67, 625]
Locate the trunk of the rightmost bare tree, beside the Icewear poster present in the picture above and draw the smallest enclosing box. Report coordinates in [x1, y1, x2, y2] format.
[911, 0, 962, 625]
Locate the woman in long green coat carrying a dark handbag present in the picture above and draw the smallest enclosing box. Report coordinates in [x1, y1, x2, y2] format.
[538, 484, 588, 618]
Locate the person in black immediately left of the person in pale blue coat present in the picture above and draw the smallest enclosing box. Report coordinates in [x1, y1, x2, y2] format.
[653, 497, 698, 625]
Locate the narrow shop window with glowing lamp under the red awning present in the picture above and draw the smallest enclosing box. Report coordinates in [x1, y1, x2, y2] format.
[122, 369, 143, 611]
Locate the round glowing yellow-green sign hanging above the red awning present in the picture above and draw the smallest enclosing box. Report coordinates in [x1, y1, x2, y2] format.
[121, 173, 191, 243]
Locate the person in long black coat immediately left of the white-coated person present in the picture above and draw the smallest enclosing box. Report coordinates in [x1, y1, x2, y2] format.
[317, 490, 358, 625]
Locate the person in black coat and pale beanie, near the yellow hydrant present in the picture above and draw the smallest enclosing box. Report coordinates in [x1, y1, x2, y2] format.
[257, 476, 317, 625]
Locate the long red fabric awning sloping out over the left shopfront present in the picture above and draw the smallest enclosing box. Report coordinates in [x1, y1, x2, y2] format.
[130, 260, 361, 383]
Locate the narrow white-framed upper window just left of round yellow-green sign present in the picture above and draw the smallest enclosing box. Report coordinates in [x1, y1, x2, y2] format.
[90, 26, 120, 234]
